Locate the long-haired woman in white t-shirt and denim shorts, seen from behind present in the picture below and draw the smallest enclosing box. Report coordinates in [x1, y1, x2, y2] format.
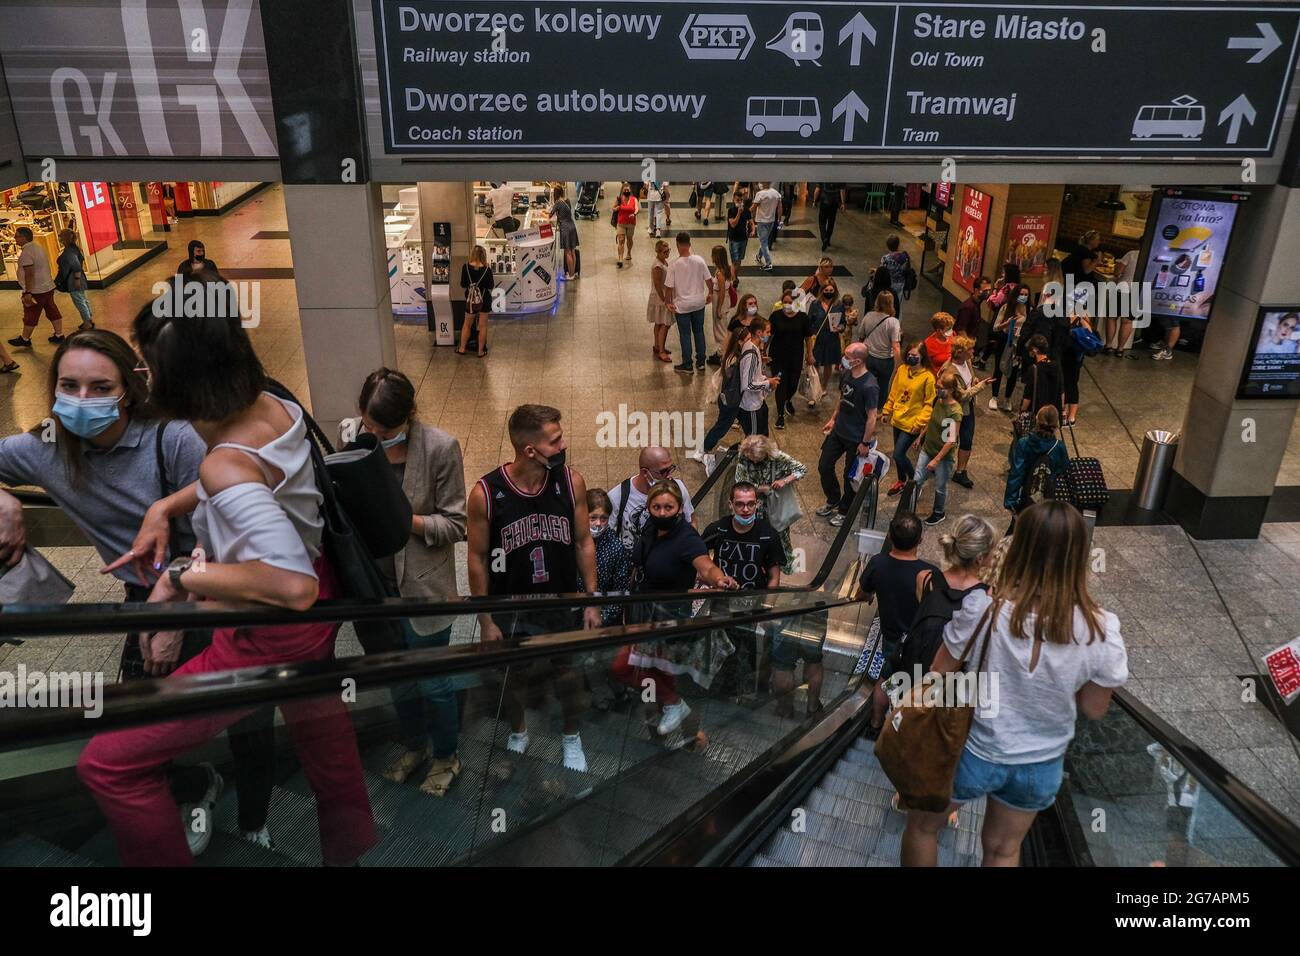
[902, 501, 1128, 866]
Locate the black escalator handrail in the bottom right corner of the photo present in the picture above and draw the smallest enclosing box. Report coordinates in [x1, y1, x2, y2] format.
[1114, 688, 1300, 866]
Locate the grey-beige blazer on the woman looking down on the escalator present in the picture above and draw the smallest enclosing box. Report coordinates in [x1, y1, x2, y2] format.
[339, 419, 465, 636]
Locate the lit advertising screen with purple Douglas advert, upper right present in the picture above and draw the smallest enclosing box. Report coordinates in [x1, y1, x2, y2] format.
[1143, 187, 1248, 321]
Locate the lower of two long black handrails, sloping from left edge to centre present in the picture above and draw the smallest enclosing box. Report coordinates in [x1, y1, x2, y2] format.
[0, 592, 854, 750]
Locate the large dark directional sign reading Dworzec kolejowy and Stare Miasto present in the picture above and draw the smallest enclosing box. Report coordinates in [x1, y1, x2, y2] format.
[374, 0, 1300, 157]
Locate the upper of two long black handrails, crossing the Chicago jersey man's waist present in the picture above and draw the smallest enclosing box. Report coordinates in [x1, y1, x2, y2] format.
[0, 463, 879, 640]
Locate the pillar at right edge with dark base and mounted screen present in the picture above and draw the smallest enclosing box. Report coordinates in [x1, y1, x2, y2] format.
[1165, 186, 1300, 538]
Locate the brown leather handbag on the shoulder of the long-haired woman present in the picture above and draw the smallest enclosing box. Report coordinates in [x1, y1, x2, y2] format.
[875, 605, 993, 813]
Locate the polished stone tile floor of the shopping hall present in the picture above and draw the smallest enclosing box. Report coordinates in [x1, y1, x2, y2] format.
[0, 187, 1300, 819]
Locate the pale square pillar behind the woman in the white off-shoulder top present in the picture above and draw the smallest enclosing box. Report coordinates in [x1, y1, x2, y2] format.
[285, 183, 397, 438]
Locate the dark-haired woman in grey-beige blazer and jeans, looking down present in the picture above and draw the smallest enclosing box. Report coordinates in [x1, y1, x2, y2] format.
[339, 368, 465, 797]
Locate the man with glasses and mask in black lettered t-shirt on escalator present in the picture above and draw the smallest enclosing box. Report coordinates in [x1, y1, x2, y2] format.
[703, 481, 780, 697]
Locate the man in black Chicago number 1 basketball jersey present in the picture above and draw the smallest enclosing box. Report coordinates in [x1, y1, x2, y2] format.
[468, 405, 601, 773]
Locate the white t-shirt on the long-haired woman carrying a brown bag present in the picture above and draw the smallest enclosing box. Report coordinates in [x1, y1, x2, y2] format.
[944, 591, 1128, 763]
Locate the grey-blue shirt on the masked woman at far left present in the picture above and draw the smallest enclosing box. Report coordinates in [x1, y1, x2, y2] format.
[0, 419, 207, 584]
